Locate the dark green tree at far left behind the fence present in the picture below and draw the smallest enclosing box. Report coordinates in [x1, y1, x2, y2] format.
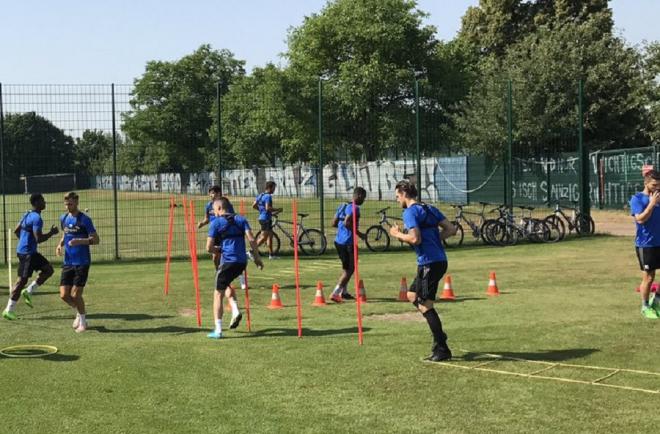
[4, 112, 74, 188]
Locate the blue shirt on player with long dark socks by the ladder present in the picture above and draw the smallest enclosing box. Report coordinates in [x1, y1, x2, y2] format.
[403, 203, 447, 265]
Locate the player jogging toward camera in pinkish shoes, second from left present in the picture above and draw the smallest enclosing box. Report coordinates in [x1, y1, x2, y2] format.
[56, 192, 100, 333]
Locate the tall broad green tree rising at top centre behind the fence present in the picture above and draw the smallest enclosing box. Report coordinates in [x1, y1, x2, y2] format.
[287, 0, 438, 160]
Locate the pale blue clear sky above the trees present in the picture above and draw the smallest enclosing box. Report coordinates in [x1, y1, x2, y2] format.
[0, 0, 660, 84]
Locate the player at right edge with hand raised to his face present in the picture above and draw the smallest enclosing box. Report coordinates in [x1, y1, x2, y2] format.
[630, 169, 660, 319]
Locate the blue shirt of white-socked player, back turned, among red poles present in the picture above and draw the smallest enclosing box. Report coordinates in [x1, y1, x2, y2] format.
[209, 214, 250, 264]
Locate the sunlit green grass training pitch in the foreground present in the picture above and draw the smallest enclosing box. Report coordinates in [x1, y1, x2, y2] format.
[0, 236, 660, 433]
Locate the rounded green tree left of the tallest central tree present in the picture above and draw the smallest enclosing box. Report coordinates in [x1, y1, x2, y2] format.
[122, 45, 244, 173]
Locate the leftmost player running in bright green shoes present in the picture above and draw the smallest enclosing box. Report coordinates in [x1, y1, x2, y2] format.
[2, 193, 59, 320]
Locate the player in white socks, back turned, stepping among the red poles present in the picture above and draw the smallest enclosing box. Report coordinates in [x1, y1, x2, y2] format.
[206, 197, 264, 339]
